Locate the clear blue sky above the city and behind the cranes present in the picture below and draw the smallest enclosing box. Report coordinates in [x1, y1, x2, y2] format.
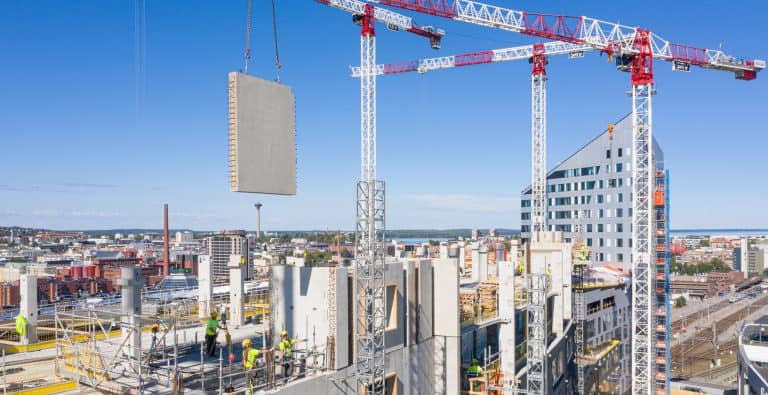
[0, 0, 768, 230]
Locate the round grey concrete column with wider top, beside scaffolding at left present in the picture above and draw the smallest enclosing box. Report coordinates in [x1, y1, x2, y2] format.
[120, 266, 144, 362]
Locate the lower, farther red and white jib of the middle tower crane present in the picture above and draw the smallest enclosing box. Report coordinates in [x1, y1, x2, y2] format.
[350, 41, 594, 78]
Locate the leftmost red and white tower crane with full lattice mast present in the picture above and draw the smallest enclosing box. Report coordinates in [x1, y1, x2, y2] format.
[316, 0, 444, 394]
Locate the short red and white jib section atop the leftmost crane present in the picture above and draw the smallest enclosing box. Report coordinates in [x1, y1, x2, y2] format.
[315, 0, 445, 49]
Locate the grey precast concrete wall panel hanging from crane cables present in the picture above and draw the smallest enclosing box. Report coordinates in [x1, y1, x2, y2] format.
[228, 72, 296, 195]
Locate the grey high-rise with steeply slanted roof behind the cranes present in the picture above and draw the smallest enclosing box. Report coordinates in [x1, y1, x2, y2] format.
[520, 115, 664, 270]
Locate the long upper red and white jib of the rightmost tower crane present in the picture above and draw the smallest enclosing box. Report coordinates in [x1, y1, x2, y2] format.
[368, 0, 766, 80]
